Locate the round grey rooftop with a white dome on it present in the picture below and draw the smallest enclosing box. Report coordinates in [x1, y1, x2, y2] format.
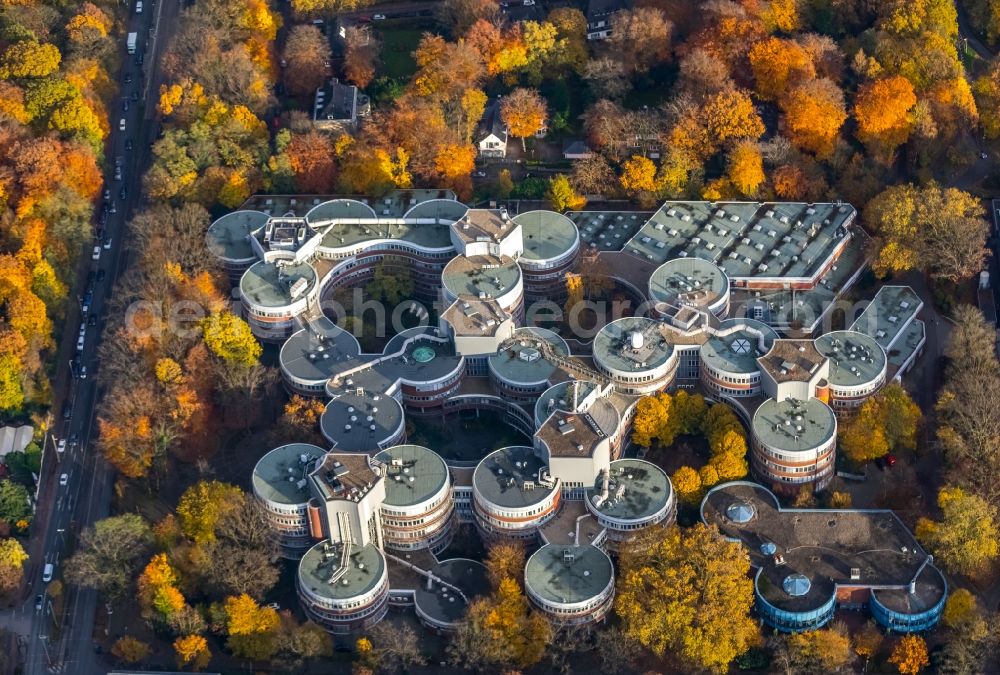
[593, 316, 674, 373]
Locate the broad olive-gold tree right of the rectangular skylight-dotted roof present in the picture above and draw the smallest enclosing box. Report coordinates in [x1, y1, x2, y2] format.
[864, 183, 988, 282]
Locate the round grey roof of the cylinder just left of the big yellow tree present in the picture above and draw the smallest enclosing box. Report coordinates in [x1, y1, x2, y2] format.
[524, 544, 615, 604]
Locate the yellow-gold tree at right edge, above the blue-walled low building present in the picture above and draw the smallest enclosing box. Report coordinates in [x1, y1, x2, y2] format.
[916, 487, 1000, 576]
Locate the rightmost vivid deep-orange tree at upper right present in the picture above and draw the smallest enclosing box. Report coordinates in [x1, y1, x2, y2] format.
[854, 75, 917, 164]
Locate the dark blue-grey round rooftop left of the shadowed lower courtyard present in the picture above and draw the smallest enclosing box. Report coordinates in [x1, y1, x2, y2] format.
[319, 391, 403, 453]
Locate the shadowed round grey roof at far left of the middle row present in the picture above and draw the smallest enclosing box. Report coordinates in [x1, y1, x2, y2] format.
[279, 316, 364, 381]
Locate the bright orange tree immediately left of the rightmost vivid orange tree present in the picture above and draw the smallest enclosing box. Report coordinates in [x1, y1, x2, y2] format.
[779, 77, 847, 159]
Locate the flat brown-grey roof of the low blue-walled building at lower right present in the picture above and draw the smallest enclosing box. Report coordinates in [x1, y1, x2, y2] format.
[701, 481, 944, 612]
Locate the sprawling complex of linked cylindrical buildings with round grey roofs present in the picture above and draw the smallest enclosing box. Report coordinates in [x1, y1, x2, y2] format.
[207, 190, 945, 633]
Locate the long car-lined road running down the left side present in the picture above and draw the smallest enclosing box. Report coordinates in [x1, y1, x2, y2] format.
[0, 0, 181, 675]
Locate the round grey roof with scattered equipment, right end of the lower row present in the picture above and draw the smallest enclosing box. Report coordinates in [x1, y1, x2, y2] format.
[587, 459, 673, 520]
